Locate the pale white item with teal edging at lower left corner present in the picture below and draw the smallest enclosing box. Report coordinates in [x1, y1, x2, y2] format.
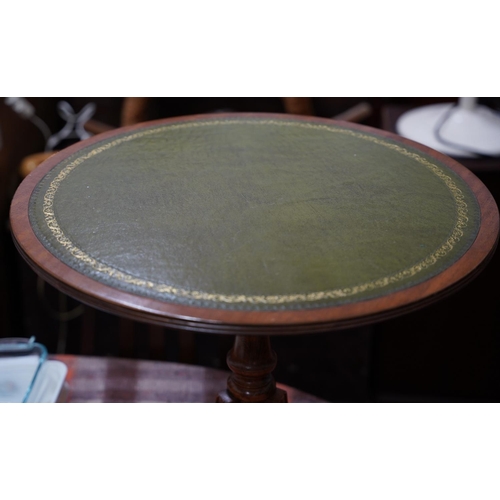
[0, 337, 47, 403]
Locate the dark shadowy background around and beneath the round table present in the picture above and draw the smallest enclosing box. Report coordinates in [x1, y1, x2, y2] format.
[0, 97, 500, 402]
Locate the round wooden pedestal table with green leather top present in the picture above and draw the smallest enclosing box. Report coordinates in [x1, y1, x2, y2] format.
[11, 113, 499, 402]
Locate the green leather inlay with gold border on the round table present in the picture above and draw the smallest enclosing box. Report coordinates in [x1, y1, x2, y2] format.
[30, 115, 480, 310]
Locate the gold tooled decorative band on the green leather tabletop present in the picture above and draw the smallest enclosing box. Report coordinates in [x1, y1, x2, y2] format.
[39, 119, 468, 305]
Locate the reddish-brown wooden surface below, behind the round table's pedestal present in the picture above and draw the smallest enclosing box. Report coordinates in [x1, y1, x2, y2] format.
[53, 355, 327, 403]
